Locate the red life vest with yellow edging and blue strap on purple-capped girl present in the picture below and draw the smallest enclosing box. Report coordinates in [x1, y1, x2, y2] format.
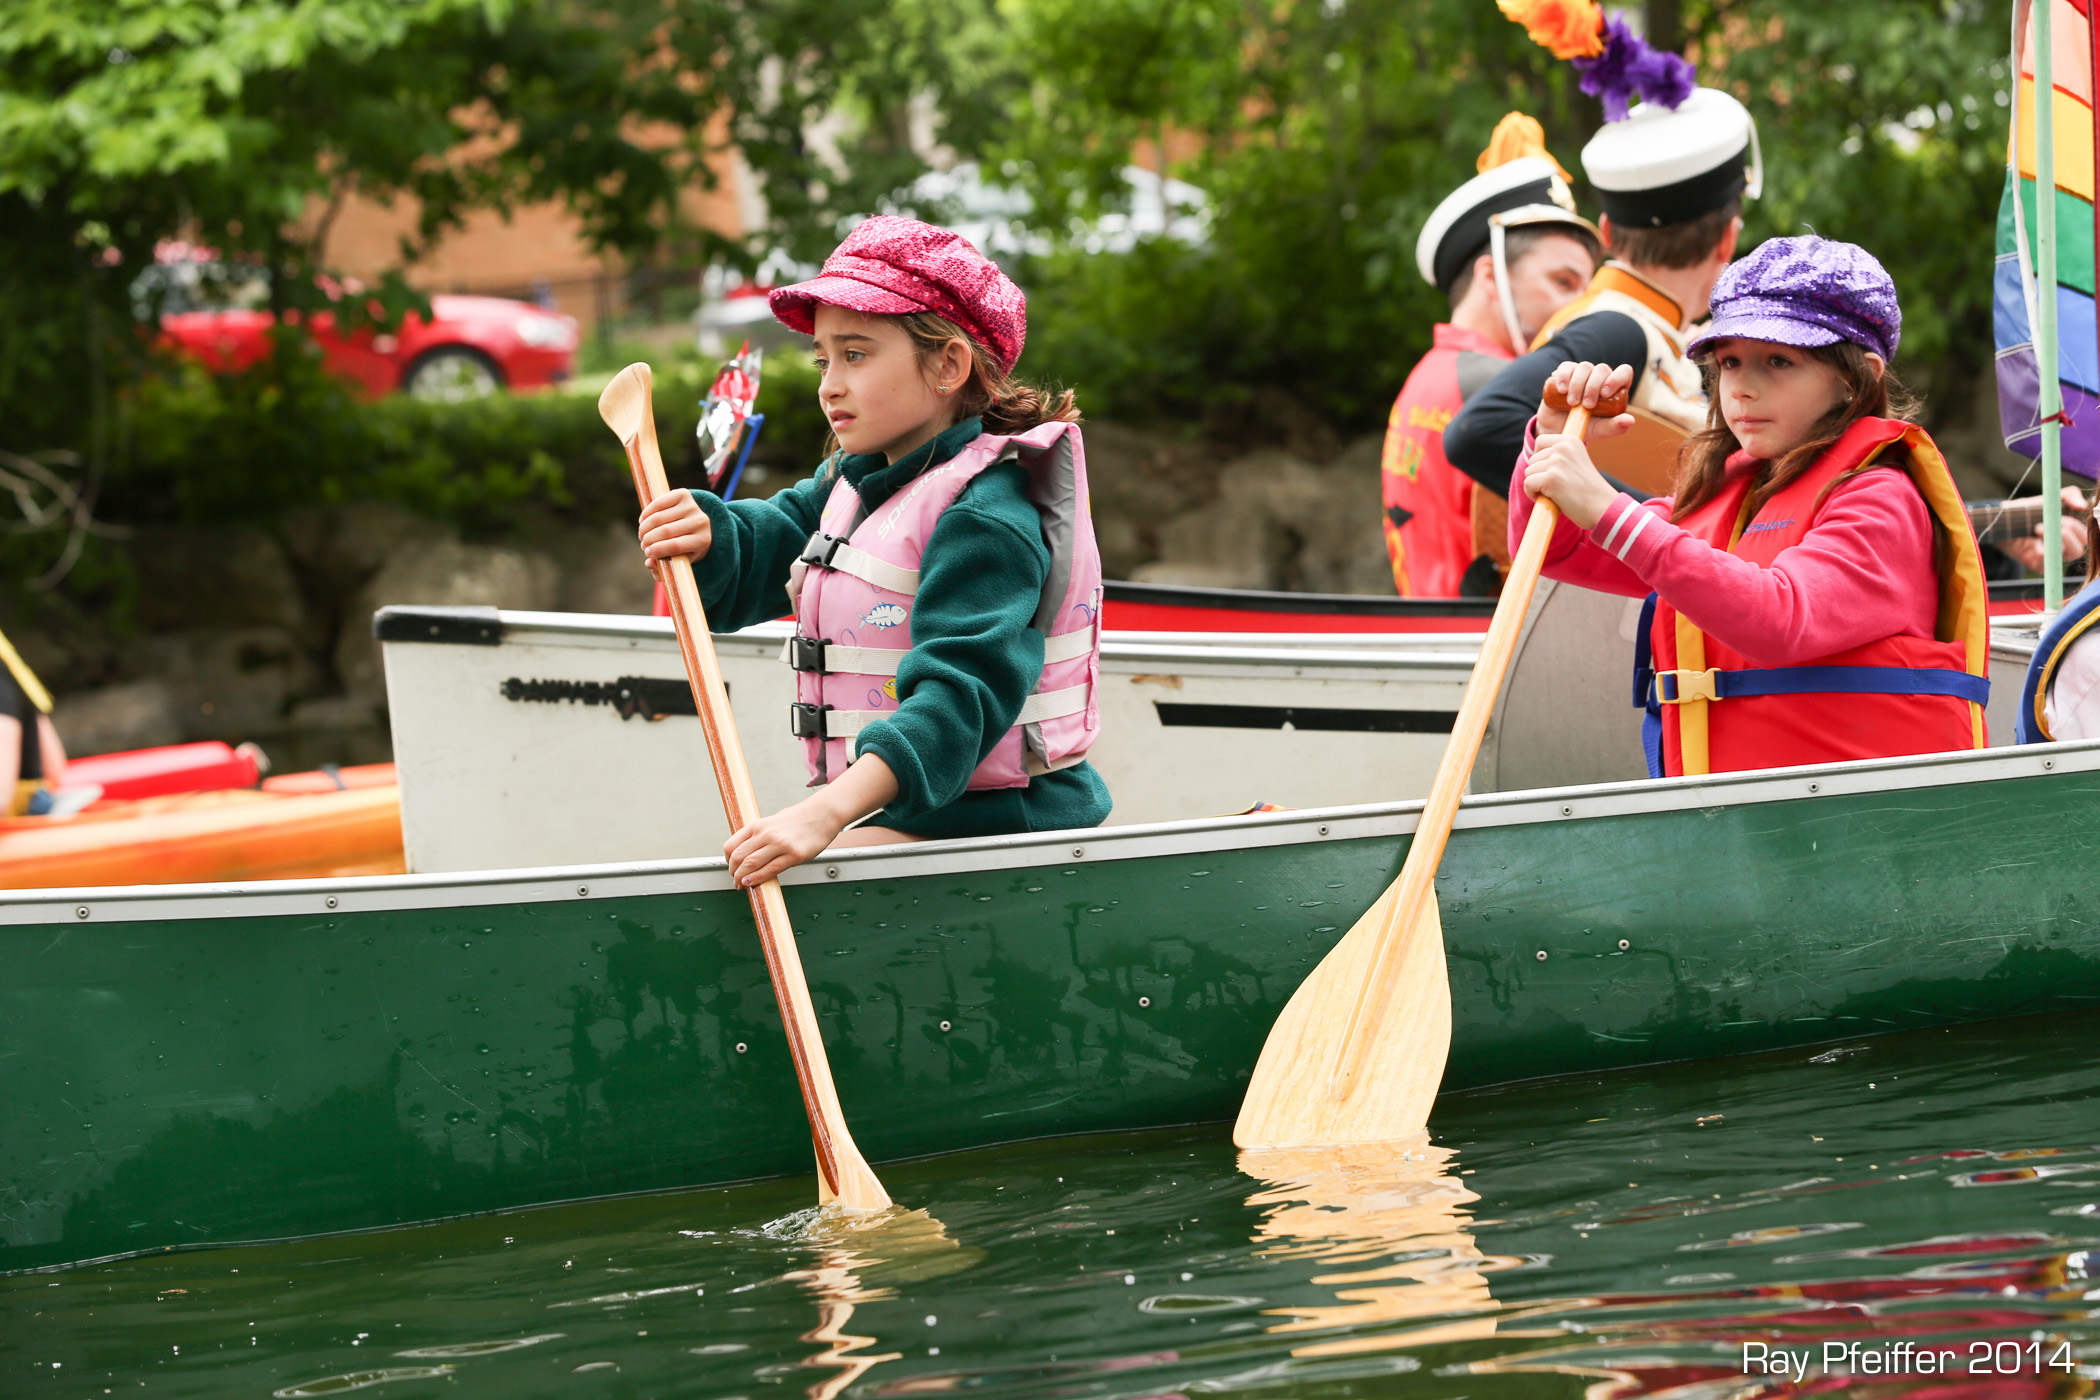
[1642, 418, 1991, 777]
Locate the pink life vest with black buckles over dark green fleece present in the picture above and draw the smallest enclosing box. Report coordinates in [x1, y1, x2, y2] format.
[781, 422, 1100, 789]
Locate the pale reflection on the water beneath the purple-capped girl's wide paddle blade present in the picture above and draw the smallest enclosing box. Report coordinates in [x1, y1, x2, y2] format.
[1239, 1136, 1518, 1356]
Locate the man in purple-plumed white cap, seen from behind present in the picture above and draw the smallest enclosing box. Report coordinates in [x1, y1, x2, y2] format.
[1445, 88, 1764, 514]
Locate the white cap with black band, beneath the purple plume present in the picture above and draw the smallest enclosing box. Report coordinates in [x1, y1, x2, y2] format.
[1581, 88, 1764, 229]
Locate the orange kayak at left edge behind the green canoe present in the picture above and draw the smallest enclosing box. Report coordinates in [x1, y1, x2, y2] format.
[0, 764, 407, 890]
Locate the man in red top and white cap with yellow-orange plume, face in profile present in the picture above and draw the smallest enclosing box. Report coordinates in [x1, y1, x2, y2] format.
[1380, 111, 1602, 598]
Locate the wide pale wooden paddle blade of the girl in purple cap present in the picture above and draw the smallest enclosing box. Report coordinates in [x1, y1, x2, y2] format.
[1233, 882, 1451, 1148]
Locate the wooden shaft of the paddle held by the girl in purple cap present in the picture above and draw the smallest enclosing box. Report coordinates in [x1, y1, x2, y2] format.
[1329, 394, 1611, 1100]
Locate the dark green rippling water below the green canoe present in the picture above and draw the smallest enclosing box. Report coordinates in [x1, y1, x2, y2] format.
[12, 1020, 2100, 1400]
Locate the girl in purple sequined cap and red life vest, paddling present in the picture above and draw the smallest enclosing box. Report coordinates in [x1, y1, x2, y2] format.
[1510, 237, 1989, 777]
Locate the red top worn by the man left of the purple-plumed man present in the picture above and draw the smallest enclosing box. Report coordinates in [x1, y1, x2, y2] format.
[1378, 323, 1514, 598]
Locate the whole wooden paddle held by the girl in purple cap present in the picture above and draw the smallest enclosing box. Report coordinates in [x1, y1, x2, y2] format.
[1233, 384, 1625, 1148]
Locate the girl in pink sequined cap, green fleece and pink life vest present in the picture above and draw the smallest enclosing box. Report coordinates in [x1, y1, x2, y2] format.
[641, 216, 1109, 884]
